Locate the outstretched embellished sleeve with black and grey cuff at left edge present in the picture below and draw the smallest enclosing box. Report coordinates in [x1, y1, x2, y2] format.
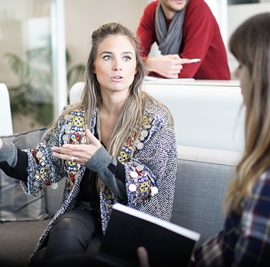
[0, 126, 66, 195]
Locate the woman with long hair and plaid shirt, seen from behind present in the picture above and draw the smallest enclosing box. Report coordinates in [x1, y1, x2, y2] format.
[138, 13, 270, 267]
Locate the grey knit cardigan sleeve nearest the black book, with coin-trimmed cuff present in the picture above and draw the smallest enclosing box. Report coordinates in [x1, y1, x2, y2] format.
[122, 105, 177, 221]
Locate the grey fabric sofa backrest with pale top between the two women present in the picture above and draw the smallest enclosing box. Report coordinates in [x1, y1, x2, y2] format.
[171, 146, 242, 248]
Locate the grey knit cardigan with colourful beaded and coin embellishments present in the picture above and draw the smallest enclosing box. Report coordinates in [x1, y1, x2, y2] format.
[16, 101, 177, 257]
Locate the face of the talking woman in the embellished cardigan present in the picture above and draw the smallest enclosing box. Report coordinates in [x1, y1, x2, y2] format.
[94, 35, 137, 97]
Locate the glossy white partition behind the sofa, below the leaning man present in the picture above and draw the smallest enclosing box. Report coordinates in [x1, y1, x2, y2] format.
[69, 79, 244, 151]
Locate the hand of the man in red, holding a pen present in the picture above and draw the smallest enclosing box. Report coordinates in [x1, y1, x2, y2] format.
[146, 54, 190, 79]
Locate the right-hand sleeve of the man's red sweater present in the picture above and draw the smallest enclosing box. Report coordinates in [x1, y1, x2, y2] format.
[178, 0, 230, 80]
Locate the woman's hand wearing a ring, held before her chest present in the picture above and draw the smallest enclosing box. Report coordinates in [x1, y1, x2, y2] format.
[52, 129, 102, 165]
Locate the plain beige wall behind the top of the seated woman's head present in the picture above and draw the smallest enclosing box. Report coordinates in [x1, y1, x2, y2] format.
[65, 0, 147, 72]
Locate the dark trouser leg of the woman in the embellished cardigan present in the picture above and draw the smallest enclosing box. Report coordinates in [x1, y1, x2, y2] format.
[29, 203, 101, 267]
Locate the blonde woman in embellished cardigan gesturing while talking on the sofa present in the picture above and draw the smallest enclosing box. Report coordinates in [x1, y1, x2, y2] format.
[0, 23, 177, 266]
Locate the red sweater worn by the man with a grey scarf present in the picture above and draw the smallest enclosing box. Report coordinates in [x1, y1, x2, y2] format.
[137, 0, 230, 80]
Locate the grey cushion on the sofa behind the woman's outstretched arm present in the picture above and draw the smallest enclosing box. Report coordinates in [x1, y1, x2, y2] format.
[0, 128, 48, 222]
